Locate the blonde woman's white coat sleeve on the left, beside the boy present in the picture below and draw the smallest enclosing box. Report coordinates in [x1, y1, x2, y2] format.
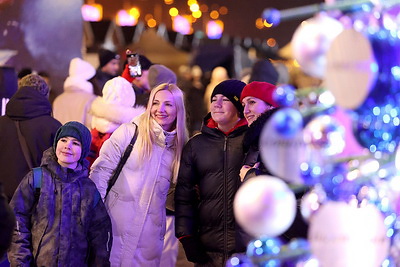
[89, 123, 136, 200]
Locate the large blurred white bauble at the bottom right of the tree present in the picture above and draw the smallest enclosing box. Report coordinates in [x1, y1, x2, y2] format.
[308, 201, 390, 267]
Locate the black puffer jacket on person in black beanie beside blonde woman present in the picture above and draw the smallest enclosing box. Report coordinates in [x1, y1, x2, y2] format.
[175, 114, 247, 266]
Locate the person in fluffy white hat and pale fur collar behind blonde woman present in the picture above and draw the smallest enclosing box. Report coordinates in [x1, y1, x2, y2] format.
[86, 77, 145, 167]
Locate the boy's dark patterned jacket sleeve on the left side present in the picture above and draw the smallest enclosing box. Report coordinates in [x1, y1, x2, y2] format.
[8, 172, 35, 266]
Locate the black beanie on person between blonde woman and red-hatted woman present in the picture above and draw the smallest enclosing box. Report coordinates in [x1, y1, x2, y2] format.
[210, 80, 246, 117]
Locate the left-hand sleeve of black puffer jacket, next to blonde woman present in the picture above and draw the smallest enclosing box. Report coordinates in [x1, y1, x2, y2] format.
[175, 141, 198, 239]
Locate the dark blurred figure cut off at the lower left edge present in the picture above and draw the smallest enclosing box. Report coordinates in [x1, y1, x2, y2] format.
[0, 183, 15, 266]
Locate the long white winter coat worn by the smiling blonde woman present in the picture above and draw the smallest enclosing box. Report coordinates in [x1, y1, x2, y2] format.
[90, 121, 176, 267]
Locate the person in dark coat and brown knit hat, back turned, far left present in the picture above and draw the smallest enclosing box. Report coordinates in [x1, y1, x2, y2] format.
[0, 74, 61, 199]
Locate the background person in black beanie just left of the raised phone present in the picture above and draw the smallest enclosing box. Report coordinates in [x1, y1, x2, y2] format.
[94, 49, 120, 96]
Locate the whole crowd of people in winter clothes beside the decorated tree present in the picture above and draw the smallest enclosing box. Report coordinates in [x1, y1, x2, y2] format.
[0, 49, 307, 267]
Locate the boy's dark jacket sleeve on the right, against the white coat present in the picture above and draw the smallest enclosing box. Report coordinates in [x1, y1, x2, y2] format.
[88, 192, 112, 266]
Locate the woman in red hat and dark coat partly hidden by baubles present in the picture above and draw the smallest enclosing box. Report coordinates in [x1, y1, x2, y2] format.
[240, 82, 308, 241]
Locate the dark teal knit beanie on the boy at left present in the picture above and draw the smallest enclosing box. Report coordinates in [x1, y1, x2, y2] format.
[53, 121, 92, 163]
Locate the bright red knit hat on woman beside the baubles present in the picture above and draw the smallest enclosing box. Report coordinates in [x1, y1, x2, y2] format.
[240, 82, 279, 107]
